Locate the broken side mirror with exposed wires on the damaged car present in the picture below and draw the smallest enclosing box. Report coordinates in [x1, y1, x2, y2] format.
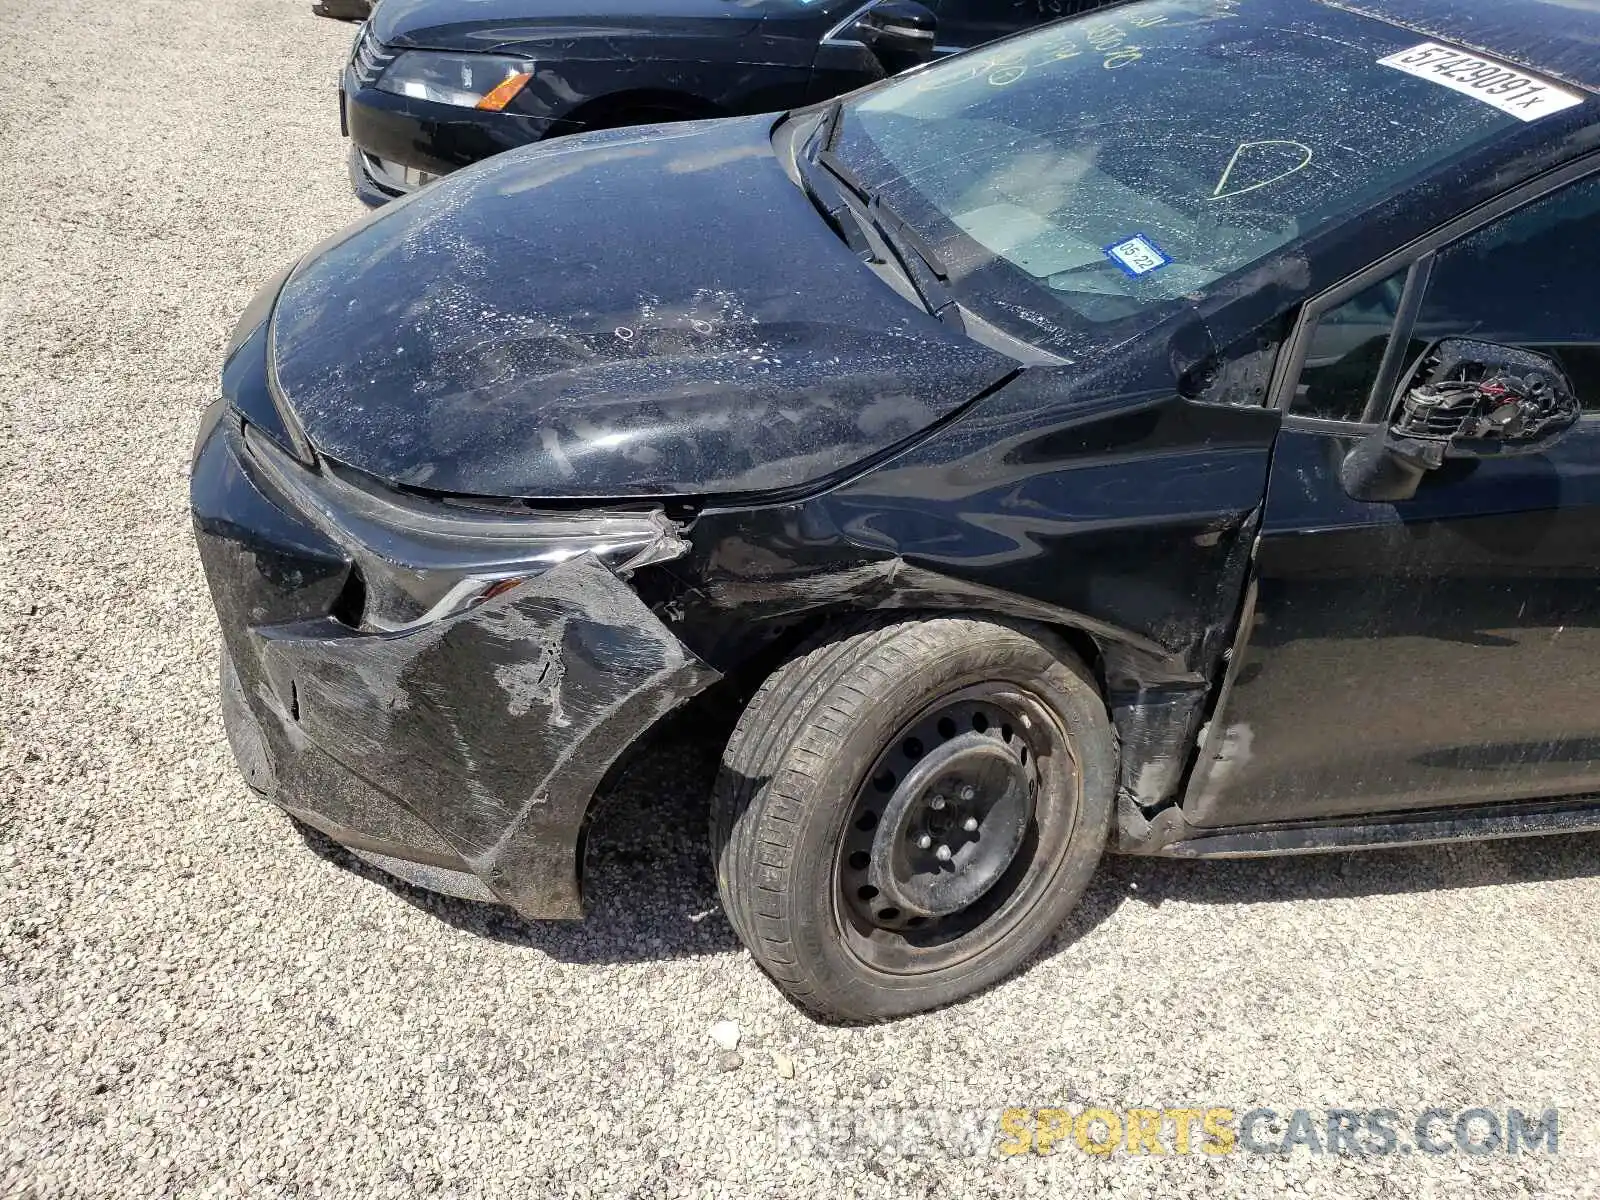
[1339, 338, 1581, 502]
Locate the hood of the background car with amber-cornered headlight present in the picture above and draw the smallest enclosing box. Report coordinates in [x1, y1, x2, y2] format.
[371, 0, 762, 50]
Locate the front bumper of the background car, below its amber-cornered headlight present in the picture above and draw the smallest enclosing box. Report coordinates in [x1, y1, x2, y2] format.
[339, 69, 582, 205]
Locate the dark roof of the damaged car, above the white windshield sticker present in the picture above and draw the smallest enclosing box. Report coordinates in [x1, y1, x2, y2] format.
[1323, 0, 1600, 91]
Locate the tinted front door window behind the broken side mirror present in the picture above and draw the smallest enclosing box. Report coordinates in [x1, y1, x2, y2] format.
[1416, 171, 1600, 411]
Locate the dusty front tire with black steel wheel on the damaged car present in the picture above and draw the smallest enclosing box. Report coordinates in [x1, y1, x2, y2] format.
[712, 618, 1115, 1021]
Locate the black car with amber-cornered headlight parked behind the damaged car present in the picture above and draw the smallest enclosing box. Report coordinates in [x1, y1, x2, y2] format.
[339, 0, 1107, 205]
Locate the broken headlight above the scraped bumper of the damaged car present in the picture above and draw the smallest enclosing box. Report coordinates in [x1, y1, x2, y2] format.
[242, 424, 688, 632]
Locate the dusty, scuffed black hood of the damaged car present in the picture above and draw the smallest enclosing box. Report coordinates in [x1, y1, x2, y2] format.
[272, 117, 1016, 498]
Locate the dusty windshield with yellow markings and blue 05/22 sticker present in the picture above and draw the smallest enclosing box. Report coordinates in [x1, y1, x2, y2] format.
[834, 0, 1576, 349]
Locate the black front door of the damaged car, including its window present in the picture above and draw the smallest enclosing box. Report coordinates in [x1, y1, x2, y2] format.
[1184, 171, 1600, 826]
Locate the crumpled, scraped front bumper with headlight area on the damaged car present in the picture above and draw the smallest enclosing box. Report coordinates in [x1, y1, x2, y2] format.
[190, 403, 717, 917]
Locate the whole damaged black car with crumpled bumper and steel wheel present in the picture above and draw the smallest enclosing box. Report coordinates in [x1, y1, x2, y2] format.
[192, 0, 1600, 1019]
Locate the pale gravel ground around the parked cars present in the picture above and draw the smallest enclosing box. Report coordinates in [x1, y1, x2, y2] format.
[0, 0, 1600, 1197]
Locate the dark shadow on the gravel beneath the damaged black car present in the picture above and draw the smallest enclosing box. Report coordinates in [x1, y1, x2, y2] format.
[299, 714, 1600, 963]
